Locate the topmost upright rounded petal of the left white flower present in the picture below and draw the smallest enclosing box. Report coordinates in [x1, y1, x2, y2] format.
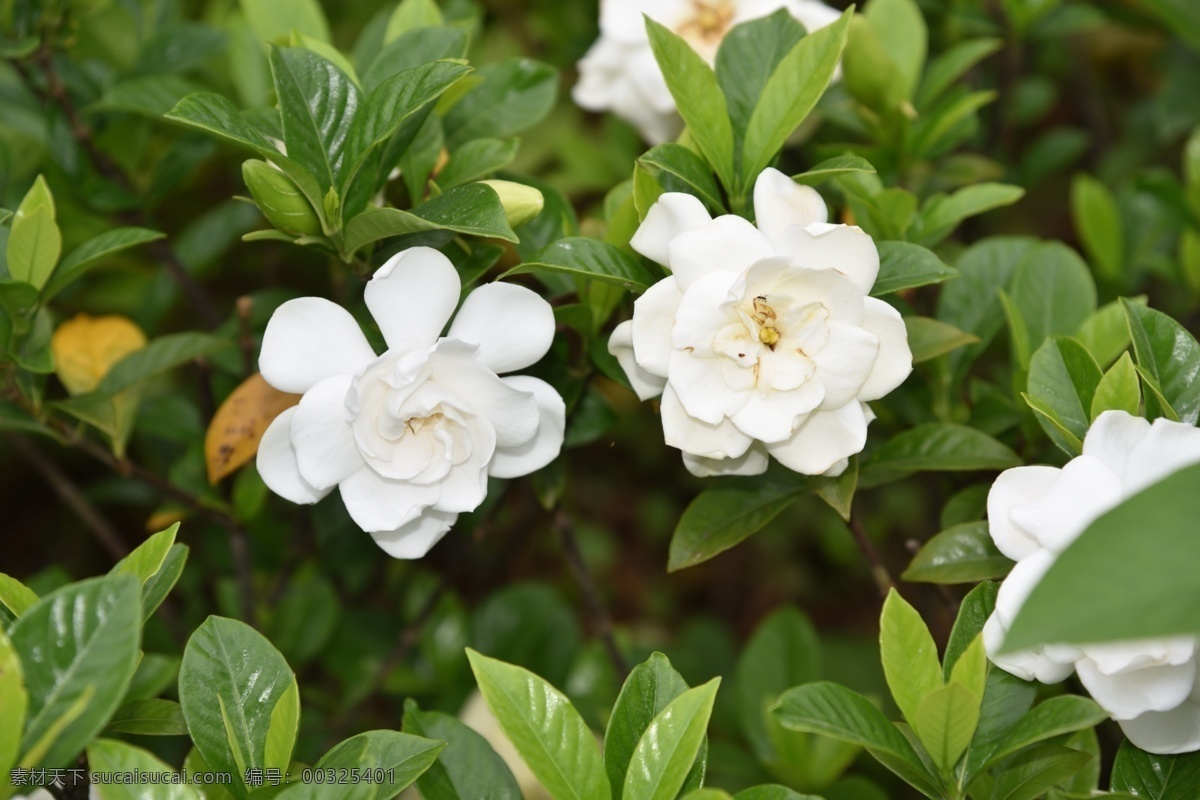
[364, 247, 462, 349]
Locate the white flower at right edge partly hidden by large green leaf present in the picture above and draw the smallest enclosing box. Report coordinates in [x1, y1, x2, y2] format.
[983, 411, 1200, 753]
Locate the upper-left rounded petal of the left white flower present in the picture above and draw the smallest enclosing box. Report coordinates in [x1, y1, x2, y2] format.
[258, 297, 374, 395]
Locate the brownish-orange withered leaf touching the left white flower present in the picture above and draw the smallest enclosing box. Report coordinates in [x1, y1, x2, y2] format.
[204, 373, 300, 483]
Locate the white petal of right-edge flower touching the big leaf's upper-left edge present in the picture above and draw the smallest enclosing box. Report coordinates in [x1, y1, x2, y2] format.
[1010, 456, 1122, 553]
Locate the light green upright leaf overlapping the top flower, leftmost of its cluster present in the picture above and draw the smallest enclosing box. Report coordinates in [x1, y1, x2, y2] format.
[646, 17, 729, 191]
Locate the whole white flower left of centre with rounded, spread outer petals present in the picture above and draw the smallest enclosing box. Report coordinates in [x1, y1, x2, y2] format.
[258, 247, 565, 558]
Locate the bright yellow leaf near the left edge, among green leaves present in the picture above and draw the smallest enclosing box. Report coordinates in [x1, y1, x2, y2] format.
[50, 314, 146, 395]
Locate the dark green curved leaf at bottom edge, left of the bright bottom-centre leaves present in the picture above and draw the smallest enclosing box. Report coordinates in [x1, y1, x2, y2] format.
[404, 699, 522, 800]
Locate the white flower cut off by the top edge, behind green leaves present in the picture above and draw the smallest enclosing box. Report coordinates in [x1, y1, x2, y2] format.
[572, 0, 841, 144]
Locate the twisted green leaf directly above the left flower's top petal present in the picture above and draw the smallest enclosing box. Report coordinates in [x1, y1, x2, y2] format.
[346, 184, 517, 253]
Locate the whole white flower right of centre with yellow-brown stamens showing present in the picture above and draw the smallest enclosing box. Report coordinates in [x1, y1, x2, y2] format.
[608, 169, 912, 476]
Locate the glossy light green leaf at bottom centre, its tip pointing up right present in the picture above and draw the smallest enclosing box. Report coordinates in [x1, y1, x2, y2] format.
[620, 678, 721, 800]
